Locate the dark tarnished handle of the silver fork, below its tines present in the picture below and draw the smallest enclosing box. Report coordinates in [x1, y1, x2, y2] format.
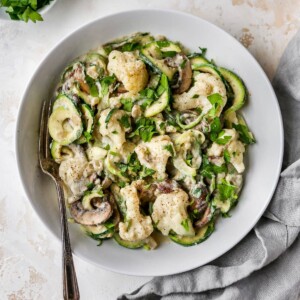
[55, 180, 80, 300]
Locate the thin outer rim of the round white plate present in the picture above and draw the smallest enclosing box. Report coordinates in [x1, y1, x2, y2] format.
[14, 8, 284, 277]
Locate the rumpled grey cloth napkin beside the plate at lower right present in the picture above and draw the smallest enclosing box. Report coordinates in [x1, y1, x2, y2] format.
[119, 32, 300, 300]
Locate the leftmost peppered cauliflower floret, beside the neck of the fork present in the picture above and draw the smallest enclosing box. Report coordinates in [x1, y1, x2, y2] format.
[59, 145, 103, 203]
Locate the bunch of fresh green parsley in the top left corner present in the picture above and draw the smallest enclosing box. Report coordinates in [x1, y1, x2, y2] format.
[0, 0, 53, 23]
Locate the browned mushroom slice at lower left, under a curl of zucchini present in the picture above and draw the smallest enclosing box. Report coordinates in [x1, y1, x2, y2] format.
[70, 201, 113, 226]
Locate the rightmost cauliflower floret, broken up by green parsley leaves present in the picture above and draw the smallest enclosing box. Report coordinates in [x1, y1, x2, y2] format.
[207, 129, 245, 173]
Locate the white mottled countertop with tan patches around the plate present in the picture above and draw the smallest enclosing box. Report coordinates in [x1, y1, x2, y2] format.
[0, 0, 300, 300]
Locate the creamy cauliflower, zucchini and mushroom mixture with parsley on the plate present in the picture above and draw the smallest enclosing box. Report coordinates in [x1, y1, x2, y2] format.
[48, 33, 255, 249]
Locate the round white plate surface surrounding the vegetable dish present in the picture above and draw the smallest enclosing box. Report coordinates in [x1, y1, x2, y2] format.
[16, 10, 283, 276]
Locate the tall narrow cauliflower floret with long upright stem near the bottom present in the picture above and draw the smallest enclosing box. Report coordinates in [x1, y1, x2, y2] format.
[119, 182, 153, 242]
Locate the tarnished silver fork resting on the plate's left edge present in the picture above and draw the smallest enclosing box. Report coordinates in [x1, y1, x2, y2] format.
[39, 100, 80, 300]
